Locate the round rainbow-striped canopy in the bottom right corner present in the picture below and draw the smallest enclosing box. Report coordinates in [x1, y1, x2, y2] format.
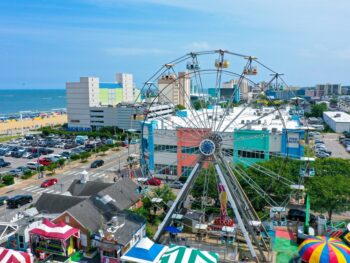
[299, 236, 350, 263]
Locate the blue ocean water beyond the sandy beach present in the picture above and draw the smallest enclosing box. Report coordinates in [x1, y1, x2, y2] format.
[0, 89, 66, 114]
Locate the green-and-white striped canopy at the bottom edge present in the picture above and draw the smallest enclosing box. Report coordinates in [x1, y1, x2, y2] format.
[160, 245, 219, 263]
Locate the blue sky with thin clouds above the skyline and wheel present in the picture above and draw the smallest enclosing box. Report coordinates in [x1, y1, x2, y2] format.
[0, 0, 350, 89]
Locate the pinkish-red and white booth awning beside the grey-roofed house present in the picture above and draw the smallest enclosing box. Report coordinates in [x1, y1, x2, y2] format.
[29, 219, 80, 240]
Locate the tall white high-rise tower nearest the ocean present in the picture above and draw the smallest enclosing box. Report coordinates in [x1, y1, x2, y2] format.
[66, 77, 100, 130]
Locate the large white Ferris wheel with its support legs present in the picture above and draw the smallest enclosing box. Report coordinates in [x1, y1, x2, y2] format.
[140, 50, 314, 262]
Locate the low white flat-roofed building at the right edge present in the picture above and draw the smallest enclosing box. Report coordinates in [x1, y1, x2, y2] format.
[323, 111, 350, 133]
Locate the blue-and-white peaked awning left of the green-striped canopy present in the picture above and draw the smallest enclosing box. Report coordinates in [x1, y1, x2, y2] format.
[121, 237, 168, 263]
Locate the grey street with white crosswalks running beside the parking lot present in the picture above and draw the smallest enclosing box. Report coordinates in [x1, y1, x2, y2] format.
[0, 147, 137, 222]
